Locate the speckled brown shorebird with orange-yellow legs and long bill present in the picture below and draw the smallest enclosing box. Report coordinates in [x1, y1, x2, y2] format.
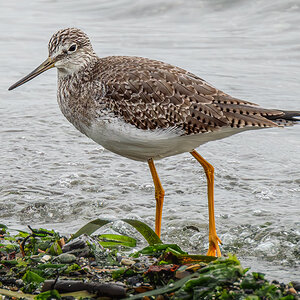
[9, 28, 300, 256]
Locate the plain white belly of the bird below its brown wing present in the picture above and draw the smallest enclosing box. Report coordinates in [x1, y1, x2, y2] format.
[84, 117, 246, 161]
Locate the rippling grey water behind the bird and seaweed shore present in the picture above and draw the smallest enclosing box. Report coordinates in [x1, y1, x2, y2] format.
[0, 0, 300, 281]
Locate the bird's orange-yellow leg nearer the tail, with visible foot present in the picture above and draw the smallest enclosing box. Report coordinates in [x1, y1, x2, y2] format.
[191, 150, 222, 256]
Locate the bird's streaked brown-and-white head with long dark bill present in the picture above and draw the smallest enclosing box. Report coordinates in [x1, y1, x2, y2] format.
[9, 28, 95, 90]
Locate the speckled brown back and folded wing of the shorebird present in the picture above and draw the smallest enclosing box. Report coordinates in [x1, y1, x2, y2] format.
[93, 56, 296, 134]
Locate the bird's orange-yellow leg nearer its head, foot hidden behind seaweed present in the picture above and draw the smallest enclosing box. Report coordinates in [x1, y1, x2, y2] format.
[148, 159, 165, 237]
